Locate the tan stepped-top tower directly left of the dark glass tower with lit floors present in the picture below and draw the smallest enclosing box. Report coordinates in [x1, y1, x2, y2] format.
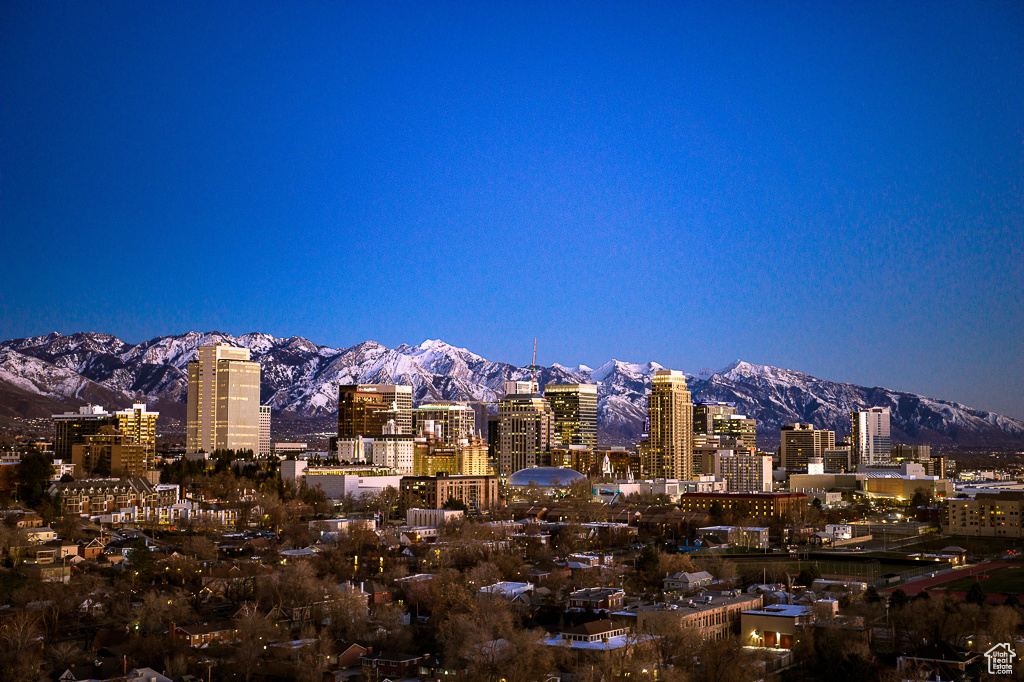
[498, 391, 555, 476]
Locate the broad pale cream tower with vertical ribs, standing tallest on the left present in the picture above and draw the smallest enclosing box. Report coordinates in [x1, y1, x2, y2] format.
[185, 343, 260, 455]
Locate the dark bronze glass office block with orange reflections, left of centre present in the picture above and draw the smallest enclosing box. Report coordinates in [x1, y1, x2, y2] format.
[338, 384, 413, 438]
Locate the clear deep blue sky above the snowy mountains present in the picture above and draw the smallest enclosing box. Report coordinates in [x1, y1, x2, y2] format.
[0, 2, 1024, 417]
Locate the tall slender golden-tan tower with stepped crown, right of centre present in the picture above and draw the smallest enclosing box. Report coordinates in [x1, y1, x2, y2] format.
[643, 370, 693, 480]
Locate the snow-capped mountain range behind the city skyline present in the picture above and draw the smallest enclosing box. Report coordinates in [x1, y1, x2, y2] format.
[0, 332, 1024, 444]
